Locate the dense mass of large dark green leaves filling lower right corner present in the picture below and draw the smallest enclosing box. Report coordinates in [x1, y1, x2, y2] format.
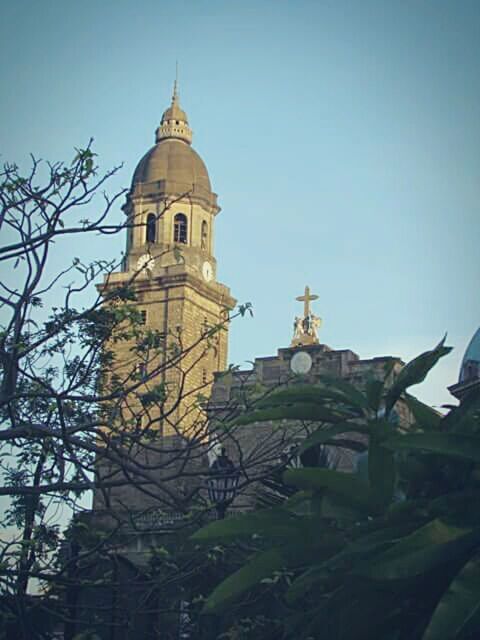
[193, 340, 480, 640]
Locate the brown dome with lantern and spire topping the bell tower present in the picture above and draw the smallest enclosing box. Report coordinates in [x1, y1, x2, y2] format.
[132, 81, 216, 207]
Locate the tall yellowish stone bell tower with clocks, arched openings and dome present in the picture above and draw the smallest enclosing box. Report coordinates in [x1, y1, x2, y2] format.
[104, 82, 236, 435]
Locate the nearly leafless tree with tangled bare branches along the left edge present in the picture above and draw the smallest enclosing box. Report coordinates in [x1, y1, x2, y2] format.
[0, 144, 300, 638]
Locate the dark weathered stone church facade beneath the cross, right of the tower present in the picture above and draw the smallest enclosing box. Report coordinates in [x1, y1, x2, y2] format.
[210, 344, 412, 509]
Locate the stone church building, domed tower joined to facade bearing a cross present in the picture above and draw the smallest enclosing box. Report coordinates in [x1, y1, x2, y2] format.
[94, 82, 410, 526]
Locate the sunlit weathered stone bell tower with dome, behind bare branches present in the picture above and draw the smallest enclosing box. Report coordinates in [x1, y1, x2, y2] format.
[94, 89, 236, 509]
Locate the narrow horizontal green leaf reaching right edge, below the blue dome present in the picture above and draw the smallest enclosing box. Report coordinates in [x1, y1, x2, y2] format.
[383, 433, 480, 462]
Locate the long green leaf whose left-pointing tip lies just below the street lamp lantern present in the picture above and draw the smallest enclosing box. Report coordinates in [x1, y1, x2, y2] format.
[192, 508, 299, 542]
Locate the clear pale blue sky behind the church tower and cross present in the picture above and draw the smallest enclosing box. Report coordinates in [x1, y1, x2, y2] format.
[0, 0, 480, 405]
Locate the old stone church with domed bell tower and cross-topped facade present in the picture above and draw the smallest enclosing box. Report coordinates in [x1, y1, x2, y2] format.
[75, 84, 480, 639]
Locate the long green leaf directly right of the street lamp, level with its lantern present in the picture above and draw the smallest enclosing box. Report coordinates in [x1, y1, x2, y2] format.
[283, 467, 380, 513]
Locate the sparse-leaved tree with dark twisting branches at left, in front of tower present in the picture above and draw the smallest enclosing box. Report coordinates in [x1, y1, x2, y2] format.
[0, 144, 296, 640]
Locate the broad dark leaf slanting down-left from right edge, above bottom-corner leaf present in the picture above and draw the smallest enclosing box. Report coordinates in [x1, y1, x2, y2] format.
[360, 519, 480, 580]
